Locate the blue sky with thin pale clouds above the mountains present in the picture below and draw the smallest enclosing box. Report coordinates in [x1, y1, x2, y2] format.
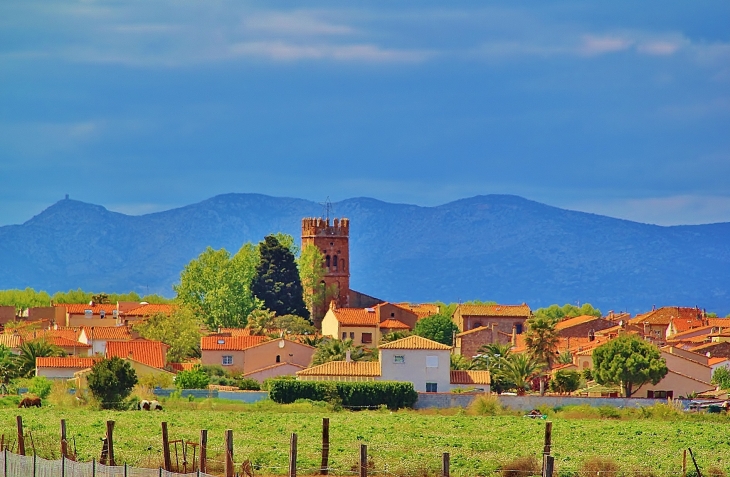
[0, 0, 730, 225]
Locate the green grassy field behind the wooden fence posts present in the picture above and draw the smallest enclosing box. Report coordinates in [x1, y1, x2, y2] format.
[0, 401, 730, 476]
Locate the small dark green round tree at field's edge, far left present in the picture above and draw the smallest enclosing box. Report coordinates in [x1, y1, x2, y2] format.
[87, 356, 137, 409]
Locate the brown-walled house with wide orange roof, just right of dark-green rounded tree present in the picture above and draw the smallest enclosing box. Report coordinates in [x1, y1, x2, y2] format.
[452, 303, 532, 335]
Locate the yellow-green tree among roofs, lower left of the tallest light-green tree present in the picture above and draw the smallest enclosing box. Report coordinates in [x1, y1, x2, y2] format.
[133, 306, 201, 363]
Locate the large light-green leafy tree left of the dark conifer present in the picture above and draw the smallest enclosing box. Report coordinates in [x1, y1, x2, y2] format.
[173, 243, 261, 330]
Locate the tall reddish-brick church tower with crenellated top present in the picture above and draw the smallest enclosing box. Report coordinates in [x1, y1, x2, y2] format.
[302, 218, 350, 314]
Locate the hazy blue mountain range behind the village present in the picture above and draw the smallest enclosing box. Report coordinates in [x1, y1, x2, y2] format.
[0, 194, 730, 314]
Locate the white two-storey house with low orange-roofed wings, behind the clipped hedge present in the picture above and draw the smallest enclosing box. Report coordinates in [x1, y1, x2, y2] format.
[297, 335, 489, 392]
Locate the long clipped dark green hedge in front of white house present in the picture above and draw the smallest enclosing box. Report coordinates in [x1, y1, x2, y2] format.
[269, 379, 418, 410]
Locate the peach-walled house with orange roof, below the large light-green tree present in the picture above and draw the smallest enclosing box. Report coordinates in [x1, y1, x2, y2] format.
[200, 335, 315, 381]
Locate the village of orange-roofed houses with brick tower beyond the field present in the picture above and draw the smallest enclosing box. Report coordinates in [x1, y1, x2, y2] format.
[0, 218, 730, 406]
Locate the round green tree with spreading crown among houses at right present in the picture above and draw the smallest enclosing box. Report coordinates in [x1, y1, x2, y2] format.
[593, 335, 669, 397]
